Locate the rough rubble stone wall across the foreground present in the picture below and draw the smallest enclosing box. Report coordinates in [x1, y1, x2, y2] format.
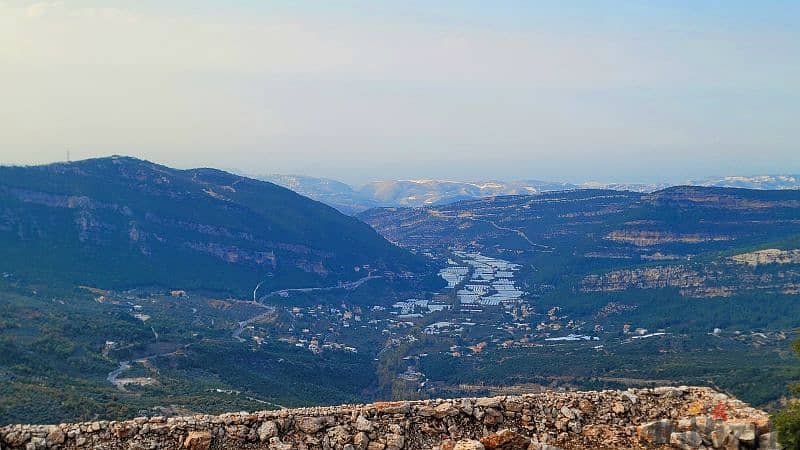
[0, 387, 778, 450]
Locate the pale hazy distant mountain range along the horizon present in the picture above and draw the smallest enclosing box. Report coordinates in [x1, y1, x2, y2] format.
[257, 175, 800, 214]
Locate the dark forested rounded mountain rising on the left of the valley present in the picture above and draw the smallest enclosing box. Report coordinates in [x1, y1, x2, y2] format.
[0, 157, 432, 293]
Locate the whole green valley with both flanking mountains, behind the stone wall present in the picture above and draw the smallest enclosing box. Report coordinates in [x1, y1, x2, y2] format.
[0, 159, 800, 423]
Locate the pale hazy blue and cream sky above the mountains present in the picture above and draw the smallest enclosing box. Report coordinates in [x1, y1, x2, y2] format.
[0, 0, 800, 184]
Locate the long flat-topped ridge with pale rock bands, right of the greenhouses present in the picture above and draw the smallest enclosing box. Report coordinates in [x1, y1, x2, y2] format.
[358, 186, 800, 280]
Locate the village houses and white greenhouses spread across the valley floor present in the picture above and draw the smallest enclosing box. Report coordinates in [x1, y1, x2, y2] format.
[90, 249, 662, 398]
